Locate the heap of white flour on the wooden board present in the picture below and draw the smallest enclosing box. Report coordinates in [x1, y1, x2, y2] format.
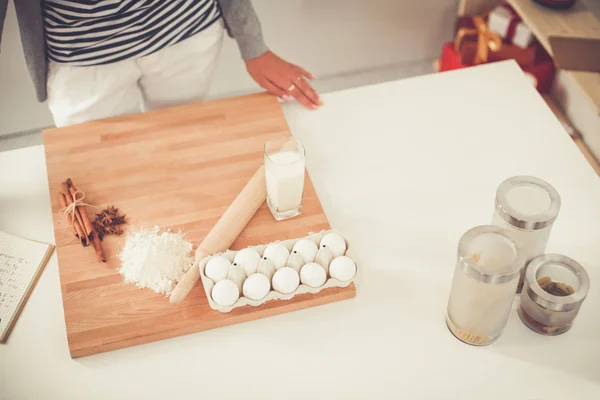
[119, 227, 194, 295]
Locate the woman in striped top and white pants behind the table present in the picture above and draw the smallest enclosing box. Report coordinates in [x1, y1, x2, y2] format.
[0, 0, 321, 126]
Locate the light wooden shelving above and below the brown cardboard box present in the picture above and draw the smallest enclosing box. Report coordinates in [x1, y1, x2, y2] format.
[508, 0, 600, 115]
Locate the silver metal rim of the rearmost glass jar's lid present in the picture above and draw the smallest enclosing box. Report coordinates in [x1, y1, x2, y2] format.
[495, 176, 560, 230]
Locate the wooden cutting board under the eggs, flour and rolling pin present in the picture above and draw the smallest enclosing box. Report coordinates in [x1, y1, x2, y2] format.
[44, 94, 356, 357]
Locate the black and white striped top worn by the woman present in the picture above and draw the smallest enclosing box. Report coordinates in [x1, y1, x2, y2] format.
[44, 0, 221, 66]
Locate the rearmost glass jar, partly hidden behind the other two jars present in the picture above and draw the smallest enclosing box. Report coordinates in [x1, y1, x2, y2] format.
[492, 176, 560, 293]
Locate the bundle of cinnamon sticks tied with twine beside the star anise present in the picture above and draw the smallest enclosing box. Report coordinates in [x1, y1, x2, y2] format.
[58, 178, 106, 262]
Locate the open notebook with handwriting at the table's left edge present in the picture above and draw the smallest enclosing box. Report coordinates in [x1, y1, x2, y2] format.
[0, 232, 54, 343]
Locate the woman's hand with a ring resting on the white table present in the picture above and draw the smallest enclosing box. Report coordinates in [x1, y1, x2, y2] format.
[246, 51, 323, 110]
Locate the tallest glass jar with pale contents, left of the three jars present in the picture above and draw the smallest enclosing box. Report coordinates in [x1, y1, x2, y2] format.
[446, 226, 525, 346]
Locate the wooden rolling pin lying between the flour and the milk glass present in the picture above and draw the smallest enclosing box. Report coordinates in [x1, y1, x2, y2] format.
[170, 165, 267, 304]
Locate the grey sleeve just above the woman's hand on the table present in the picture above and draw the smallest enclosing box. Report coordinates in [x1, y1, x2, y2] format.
[218, 0, 269, 60]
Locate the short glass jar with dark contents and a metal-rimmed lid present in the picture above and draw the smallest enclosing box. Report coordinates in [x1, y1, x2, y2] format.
[518, 254, 590, 335]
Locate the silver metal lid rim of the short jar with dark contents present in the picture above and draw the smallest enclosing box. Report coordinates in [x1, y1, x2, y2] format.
[525, 254, 590, 311]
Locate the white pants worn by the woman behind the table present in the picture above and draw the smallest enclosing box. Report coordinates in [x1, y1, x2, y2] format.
[47, 20, 224, 127]
